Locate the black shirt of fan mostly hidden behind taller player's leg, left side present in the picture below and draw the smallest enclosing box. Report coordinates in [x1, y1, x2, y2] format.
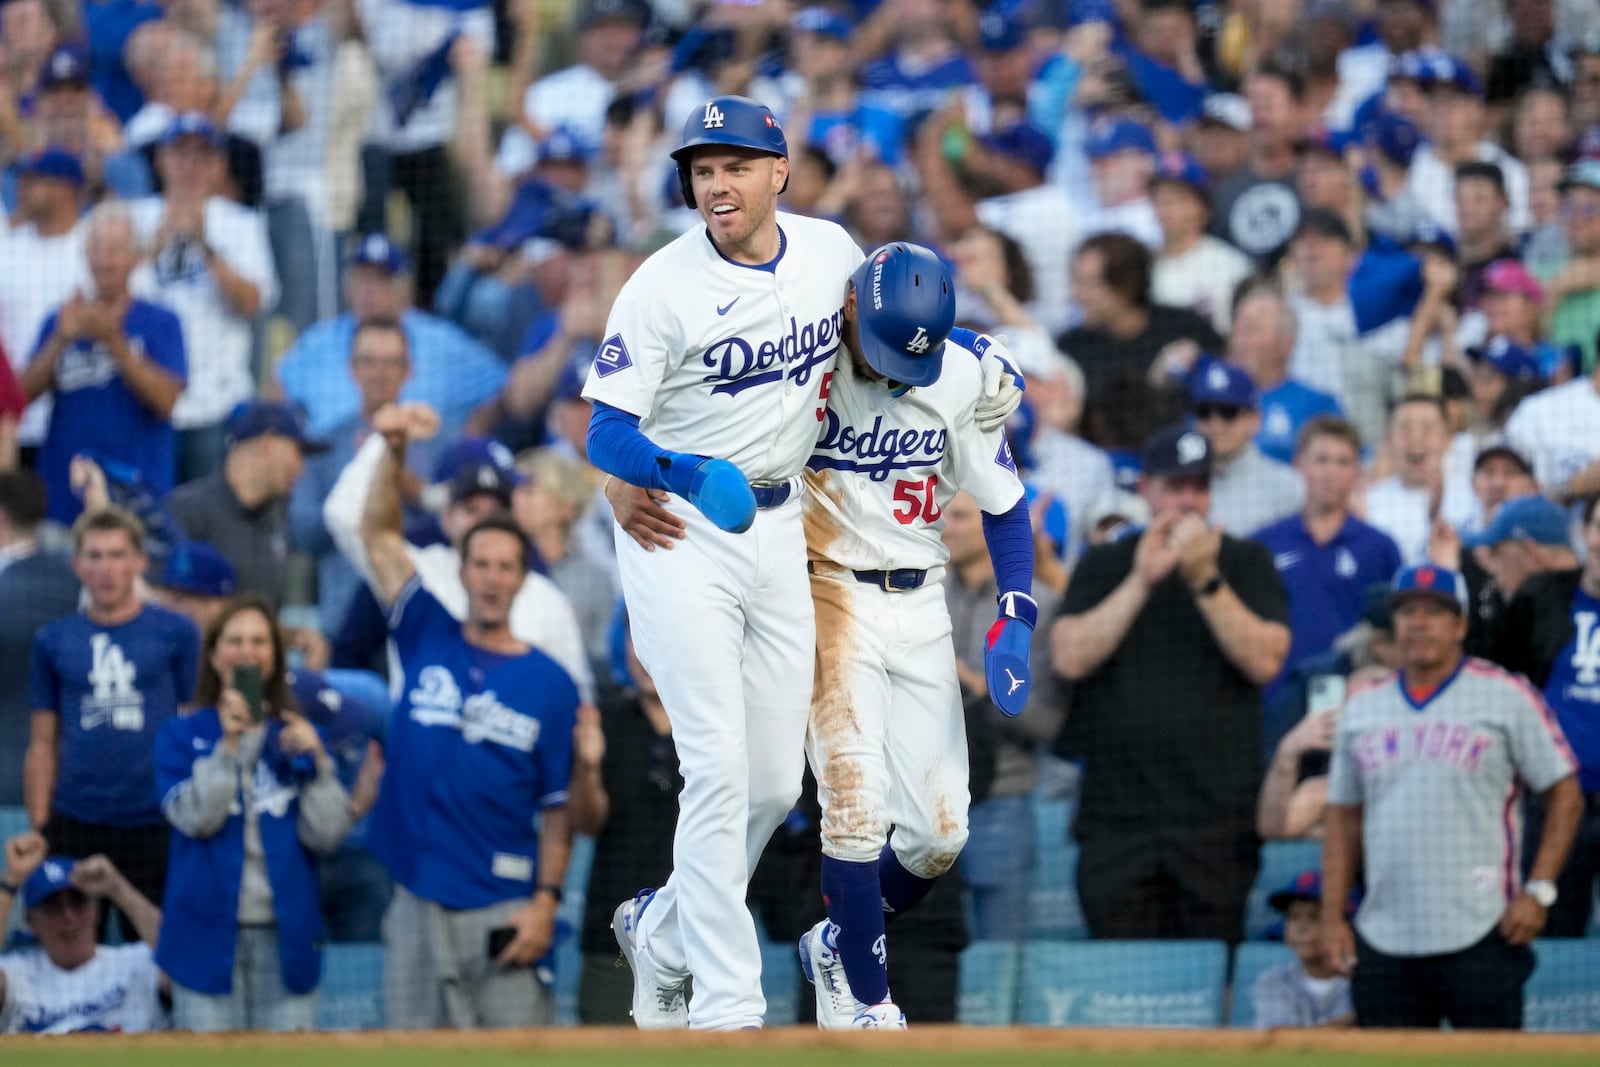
[579, 691, 683, 953]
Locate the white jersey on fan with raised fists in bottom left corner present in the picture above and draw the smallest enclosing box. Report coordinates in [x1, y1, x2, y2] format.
[0, 942, 162, 1033]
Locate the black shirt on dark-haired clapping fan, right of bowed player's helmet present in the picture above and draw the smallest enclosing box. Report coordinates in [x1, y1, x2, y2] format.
[1058, 304, 1222, 450]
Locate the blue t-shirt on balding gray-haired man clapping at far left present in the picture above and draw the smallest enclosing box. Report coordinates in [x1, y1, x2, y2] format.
[34, 301, 189, 523]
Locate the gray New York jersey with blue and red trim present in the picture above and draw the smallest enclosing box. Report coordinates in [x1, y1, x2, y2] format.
[1328, 657, 1578, 957]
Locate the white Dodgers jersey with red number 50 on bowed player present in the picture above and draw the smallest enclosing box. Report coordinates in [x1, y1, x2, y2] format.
[805, 341, 1022, 571]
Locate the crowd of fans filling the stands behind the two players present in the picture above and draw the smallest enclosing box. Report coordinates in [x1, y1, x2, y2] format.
[0, 0, 1600, 1032]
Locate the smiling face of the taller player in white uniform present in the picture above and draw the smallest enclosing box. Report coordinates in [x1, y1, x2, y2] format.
[690, 146, 789, 264]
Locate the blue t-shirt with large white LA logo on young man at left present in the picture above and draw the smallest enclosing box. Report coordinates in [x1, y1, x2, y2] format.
[29, 605, 200, 827]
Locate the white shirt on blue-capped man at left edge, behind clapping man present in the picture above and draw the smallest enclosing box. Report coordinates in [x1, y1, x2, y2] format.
[0, 224, 90, 446]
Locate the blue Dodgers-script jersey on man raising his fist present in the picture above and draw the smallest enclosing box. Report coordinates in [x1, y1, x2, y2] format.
[368, 577, 579, 909]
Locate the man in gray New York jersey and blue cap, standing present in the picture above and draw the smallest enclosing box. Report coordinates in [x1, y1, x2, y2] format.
[1322, 565, 1582, 1030]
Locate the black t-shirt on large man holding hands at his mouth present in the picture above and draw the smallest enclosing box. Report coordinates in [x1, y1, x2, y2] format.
[1058, 536, 1288, 837]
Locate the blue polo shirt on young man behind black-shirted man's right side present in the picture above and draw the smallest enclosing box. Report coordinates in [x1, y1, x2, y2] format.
[1254, 515, 1400, 701]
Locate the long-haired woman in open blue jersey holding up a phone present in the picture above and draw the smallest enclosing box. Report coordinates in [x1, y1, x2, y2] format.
[155, 593, 352, 1032]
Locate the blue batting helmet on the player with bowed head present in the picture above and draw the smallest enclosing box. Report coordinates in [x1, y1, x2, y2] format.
[850, 242, 955, 386]
